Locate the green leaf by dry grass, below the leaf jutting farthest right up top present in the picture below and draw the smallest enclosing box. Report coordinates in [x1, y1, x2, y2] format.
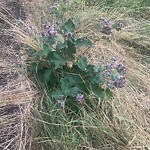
[76, 57, 87, 71]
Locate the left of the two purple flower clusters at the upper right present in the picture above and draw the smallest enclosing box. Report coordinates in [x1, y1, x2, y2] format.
[100, 17, 112, 35]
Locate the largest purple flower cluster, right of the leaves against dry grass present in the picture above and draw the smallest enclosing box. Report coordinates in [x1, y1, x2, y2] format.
[104, 57, 126, 89]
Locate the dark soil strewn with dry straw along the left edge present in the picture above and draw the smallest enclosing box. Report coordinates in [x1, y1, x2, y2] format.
[0, 0, 35, 150]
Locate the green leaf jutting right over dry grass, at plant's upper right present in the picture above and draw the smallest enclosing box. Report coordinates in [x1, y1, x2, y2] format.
[76, 38, 93, 48]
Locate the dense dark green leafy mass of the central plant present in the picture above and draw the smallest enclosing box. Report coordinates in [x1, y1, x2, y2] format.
[30, 19, 112, 115]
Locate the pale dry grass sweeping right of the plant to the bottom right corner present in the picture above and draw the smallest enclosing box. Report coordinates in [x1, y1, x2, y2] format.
[87, 41, 150, 150]
